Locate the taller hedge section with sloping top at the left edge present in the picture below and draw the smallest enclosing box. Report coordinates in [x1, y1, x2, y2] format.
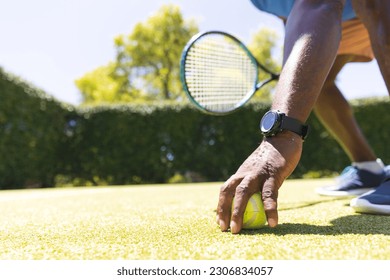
[0, 68, 70, 189]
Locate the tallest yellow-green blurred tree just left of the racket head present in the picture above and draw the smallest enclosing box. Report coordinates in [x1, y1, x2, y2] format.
[115, 5, 198, 100]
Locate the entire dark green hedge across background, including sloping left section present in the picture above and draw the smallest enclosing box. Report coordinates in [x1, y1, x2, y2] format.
[0, 66, 390, 189]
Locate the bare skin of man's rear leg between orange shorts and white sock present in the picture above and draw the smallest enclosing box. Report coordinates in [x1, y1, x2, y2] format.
[314, 55, 377, 162]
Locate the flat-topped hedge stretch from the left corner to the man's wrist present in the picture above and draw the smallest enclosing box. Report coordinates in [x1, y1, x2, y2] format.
[63, 105, 266, 184]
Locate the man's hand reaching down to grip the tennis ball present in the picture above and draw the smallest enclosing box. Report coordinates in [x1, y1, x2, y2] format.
[217, 131, 303, 233]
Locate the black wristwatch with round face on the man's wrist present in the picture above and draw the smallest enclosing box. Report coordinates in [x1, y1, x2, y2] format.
[260, 110, 309, 140]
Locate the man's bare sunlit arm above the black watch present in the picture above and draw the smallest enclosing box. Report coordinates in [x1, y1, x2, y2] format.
[272, 1, 342, 122]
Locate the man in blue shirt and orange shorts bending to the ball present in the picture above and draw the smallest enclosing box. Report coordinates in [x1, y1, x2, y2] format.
[217, 0, 390, 233]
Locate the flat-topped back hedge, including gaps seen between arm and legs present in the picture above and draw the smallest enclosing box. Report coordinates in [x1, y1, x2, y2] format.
[65, 100, 390, 184]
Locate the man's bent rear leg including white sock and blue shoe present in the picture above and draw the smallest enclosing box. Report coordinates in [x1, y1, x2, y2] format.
[314, 55, 384, 196]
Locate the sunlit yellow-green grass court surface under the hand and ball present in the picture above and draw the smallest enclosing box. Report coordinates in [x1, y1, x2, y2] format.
[0, 180, 390, 260]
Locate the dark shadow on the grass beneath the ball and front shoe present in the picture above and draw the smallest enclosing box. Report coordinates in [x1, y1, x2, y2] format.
[241, 215, 390, 236]
